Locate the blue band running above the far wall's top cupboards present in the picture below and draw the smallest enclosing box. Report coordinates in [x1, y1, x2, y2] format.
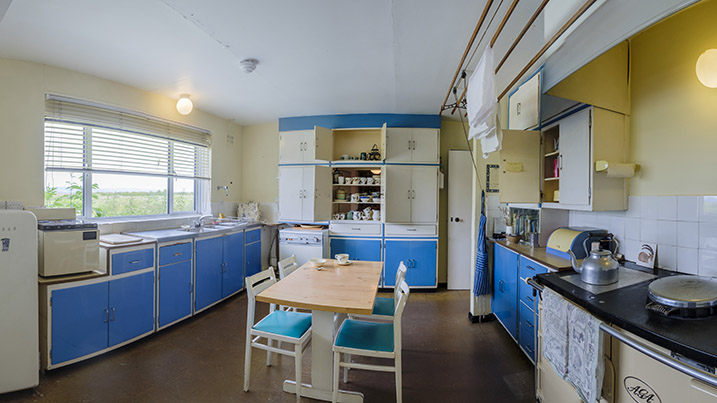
[279, 113, 441, 132]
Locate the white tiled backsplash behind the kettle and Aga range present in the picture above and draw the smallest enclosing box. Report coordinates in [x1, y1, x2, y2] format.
[569, 196, 717, 277]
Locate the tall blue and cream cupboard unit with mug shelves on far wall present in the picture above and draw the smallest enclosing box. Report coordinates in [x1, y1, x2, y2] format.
[279, 114, 441, 288]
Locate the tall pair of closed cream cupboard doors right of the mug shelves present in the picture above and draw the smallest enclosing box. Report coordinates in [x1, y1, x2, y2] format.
[385, 165, 438, 223]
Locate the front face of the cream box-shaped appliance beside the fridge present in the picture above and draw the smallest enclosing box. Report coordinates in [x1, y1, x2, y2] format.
[38, 229, 100, 276]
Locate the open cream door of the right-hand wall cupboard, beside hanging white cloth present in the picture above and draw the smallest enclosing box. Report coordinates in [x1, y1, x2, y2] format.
[499, 130, 540, 203]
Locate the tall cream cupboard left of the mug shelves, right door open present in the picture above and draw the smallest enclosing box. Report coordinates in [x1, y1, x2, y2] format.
[279, 165, 331, 222]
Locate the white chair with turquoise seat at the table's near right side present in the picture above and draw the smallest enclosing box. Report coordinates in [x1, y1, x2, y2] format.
[332, 280, 410, 403]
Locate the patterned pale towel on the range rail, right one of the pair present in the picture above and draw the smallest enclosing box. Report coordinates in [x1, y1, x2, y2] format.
[567, 304, 605, 402]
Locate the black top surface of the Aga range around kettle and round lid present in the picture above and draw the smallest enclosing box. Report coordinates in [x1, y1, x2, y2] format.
[536, 263, 717, 367]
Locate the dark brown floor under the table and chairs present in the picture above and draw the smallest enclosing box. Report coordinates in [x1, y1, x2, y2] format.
[0, 289, 535, 403]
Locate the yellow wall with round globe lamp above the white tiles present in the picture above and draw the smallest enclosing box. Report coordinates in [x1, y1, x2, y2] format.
[629, 0, 717, 195]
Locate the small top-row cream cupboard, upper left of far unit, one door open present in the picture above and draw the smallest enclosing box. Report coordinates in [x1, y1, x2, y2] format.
[279, 126, 333, 164]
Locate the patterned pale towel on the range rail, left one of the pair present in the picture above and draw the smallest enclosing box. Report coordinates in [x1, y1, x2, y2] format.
[540, 287, 570, 378]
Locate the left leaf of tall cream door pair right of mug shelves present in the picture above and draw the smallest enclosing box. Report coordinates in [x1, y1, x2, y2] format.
[384, 165, 411, 223]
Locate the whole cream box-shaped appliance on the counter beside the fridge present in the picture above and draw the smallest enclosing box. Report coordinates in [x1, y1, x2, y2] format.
[30, 209, 100, 277]
